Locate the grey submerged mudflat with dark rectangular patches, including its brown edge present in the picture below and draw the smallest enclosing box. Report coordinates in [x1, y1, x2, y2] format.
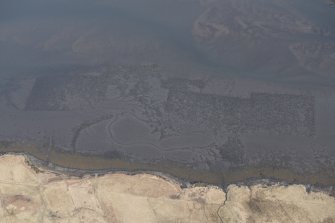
[0, 65, 335, 185]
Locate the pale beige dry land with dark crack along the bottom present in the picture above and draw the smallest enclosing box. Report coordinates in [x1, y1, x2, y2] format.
[0, 155, 335, 223]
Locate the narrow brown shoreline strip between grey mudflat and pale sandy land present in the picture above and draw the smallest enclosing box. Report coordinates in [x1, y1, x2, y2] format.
[0, 143, 335, 194]
